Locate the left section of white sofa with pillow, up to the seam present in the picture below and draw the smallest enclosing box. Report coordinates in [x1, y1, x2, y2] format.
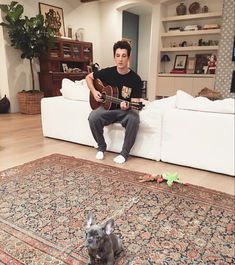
[41, 79, 162, 161]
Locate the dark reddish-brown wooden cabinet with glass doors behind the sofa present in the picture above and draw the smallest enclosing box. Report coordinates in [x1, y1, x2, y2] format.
[38, 38, 93, 97]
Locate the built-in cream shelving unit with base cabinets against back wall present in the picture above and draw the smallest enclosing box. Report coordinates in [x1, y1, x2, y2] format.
[156, 0, 223, 97]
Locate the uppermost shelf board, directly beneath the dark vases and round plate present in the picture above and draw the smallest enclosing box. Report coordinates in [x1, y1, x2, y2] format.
[162, 12, 222, 22]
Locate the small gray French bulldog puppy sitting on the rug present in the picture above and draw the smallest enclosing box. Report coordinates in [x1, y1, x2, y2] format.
[86, 213, 122, 265]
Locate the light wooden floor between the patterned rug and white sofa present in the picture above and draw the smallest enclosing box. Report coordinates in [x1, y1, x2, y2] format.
[0, 114, 235, 195]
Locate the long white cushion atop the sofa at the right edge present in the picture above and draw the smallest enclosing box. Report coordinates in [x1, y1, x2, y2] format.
[176, 90, 235, 114]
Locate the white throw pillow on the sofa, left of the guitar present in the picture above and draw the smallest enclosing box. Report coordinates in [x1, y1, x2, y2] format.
[60, 78, 90, 101]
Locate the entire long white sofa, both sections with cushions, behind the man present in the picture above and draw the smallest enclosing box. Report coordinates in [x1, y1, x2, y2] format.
[41, 79, 235, 176]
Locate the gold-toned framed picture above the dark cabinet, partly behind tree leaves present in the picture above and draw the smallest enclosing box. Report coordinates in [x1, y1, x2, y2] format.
[39, 2, 65, 37]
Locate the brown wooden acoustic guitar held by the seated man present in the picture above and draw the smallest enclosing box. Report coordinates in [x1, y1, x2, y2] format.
[90, 79, 145, 110]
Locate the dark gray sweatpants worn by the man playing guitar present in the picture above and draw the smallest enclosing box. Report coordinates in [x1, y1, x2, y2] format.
[88, 107, 140, 159]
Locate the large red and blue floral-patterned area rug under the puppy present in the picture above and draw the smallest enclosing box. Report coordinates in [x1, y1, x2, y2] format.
[0, 154, 235, 265]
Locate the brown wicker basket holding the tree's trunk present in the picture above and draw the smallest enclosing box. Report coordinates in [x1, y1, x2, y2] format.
[17, 91, 44, 114]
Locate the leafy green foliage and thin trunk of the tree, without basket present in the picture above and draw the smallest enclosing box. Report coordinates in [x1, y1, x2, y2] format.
[0, 1, 54, 89]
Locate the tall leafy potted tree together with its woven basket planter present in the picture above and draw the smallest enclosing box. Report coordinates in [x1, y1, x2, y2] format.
[0, 1, 54, 114]
